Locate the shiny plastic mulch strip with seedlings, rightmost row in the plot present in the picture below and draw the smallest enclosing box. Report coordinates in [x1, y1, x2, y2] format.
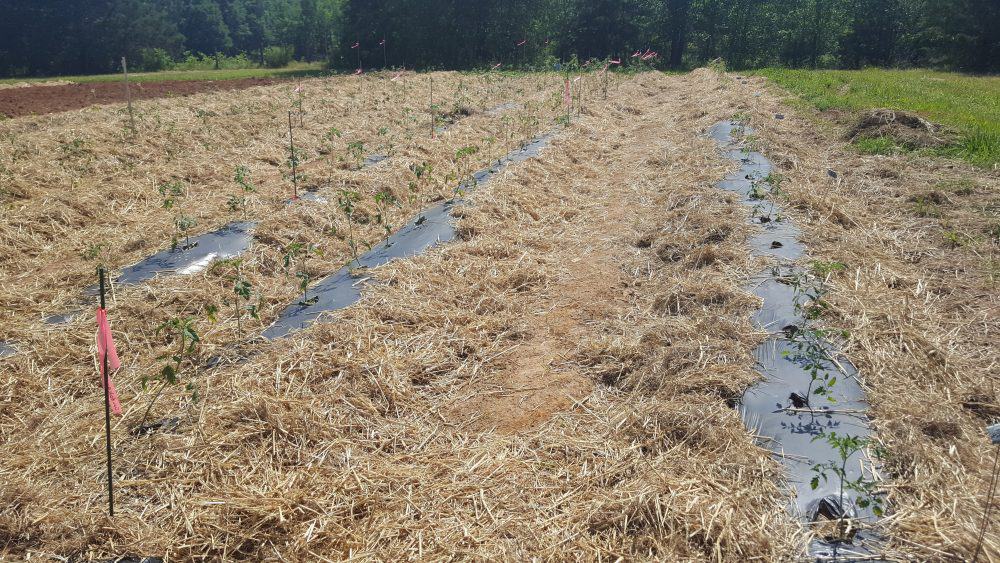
[708, 121, 878, 557]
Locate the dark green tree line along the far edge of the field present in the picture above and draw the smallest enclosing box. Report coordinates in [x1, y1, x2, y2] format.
[0, 0, 1000, 76]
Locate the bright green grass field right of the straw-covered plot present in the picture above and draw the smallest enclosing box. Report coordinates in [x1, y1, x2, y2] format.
[756, 68, 1000, 168]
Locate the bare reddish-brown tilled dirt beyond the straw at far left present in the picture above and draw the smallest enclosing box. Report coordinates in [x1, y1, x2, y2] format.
[0, 78, 290, 117]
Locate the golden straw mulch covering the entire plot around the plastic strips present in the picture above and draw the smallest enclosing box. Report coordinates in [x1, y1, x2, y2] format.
[0, 66, 997, 561]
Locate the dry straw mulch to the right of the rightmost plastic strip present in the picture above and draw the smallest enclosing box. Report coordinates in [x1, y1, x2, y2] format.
[722, 74, 1000, 561]
